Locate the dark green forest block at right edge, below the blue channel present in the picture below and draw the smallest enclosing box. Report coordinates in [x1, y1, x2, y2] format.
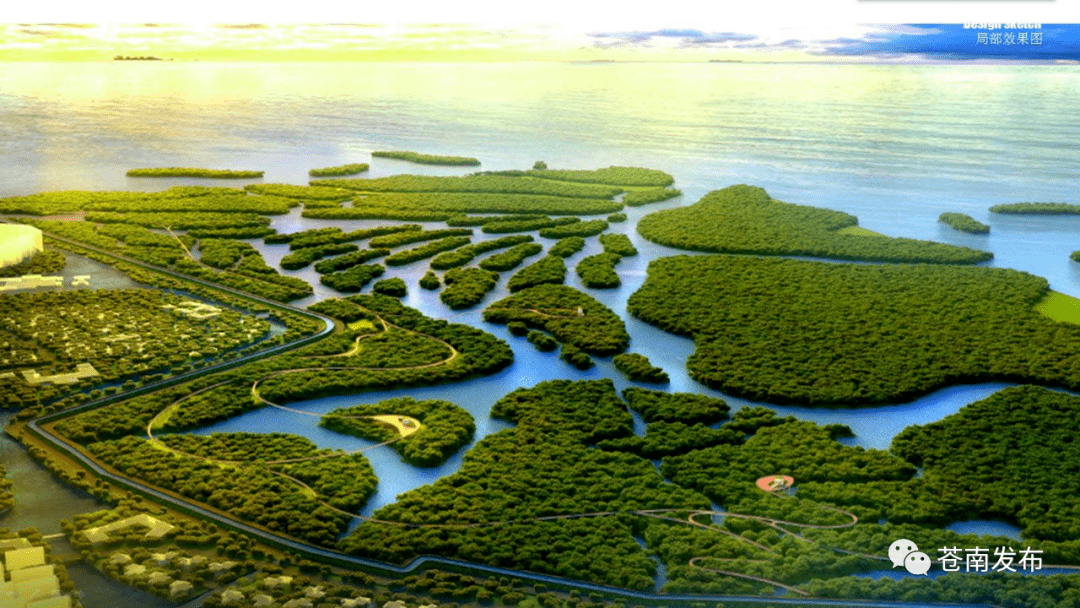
[892, 387, 1080, 539]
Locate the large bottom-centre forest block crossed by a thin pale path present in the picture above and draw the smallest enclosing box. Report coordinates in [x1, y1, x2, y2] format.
[341, 380, 708, 590]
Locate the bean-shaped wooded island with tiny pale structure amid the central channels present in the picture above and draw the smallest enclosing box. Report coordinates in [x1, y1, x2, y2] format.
[484, 285, 630, 356]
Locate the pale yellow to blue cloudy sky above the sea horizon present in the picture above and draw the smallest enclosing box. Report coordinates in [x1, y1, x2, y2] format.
[6, 0, 1080, 63]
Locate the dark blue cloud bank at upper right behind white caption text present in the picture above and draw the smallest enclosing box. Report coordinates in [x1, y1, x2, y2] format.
[811, 24, 1080, 60]
